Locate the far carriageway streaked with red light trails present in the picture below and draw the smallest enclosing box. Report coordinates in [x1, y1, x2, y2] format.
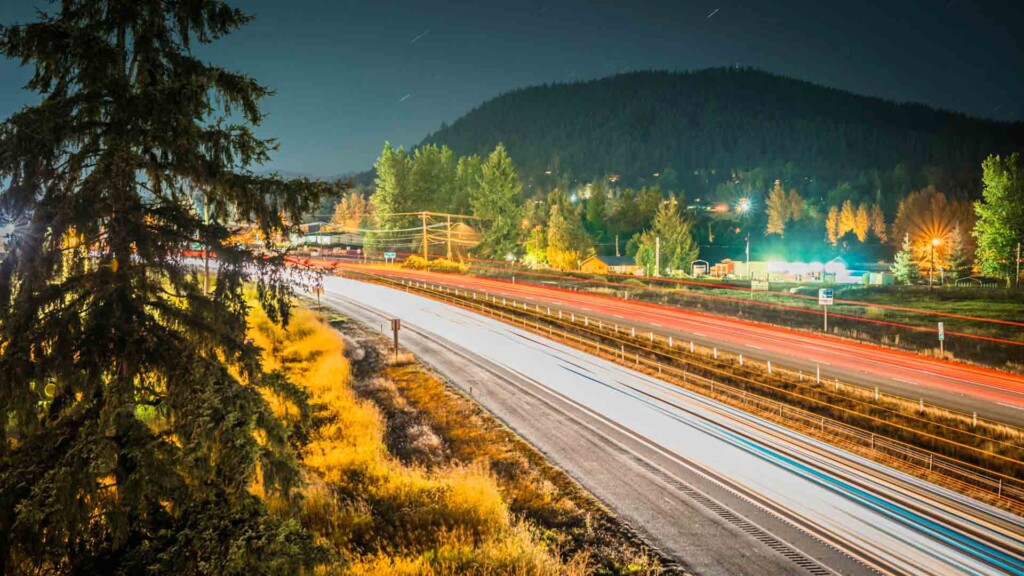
[339, 266, 1024, 425]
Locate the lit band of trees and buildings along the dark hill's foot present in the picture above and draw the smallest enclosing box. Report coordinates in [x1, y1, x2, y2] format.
[362, 145, 1024, 282]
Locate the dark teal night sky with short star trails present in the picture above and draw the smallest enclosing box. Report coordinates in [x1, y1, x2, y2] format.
[0, 0, 1024, 176]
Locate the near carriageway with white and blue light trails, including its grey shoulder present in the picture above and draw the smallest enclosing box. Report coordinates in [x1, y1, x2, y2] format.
[324, 277, 1024, 575]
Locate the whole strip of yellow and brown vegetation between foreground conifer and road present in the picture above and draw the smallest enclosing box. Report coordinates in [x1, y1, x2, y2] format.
[244, 303, 657, 575]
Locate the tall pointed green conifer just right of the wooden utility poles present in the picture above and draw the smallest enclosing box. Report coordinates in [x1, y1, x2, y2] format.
[471, 145, 522, 259]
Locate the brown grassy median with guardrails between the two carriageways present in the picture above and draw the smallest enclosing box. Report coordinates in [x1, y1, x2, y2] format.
[348, 272, 1024, 513]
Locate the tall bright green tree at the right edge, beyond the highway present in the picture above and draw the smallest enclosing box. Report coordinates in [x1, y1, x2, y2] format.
[972, 153, 1024, 286]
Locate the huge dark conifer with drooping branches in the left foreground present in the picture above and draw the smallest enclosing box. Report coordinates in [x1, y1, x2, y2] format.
[0, 0, 327, 575]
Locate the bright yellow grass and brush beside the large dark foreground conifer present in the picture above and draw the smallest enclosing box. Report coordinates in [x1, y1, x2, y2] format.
[249, 310, 569, 574]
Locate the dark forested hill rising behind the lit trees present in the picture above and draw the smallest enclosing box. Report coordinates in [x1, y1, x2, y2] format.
[425, 68, 1024, 196]
